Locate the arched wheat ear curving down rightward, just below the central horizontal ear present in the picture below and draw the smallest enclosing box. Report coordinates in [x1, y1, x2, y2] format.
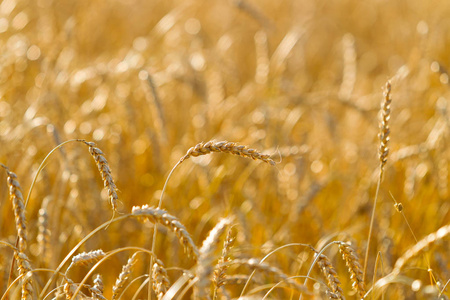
[132, 205, 199, 260]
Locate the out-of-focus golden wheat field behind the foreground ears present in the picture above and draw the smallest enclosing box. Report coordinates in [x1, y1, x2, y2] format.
[0, 0, 450, 299]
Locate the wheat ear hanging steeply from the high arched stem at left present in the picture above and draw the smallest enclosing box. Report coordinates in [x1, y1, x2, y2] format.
[80, 140, 119, 212]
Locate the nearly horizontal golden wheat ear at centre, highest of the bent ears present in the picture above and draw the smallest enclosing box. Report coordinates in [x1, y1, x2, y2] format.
[180, 141, 275, 166]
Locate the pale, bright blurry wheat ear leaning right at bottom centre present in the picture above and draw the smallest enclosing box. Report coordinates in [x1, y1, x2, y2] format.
[194, 218, 231, 299]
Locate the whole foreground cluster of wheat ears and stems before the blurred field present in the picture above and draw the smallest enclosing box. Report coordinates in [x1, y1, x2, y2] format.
[1, 86, 450, 299]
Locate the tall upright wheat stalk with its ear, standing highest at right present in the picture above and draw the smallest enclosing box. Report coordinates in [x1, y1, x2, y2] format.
[363, 81, 392, 282]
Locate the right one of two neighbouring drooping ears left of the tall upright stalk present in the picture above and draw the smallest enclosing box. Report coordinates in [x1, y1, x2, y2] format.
[339, 243, 366, 299]
